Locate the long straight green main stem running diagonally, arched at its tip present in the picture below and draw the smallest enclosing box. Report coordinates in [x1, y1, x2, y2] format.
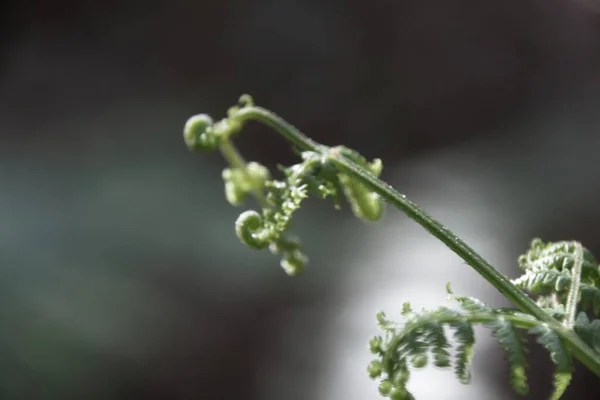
[227, 106, 600, 376]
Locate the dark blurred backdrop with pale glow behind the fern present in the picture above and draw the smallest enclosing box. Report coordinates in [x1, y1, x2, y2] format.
[0, 0, 600, 400]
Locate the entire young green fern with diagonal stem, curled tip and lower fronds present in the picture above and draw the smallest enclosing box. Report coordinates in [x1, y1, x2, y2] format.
[184, 95, 600, 400]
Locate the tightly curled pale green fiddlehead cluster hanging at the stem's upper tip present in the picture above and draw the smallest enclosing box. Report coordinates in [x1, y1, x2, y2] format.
[184, 95, 383, 275]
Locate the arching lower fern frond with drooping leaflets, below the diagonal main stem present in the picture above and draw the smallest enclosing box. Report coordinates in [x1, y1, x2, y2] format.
[369, 286, 600, 400]
